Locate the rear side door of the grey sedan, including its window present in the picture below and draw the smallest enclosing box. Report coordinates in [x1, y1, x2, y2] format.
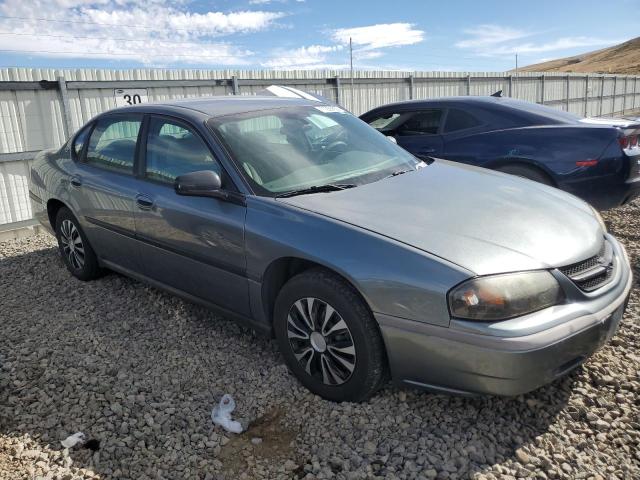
[70, 114, 142, 271]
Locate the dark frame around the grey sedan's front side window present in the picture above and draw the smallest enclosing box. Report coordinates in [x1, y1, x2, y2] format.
[140, 113, 239, 193]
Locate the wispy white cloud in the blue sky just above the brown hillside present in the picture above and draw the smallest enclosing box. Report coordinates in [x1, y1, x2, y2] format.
[455, 25, 620, 57]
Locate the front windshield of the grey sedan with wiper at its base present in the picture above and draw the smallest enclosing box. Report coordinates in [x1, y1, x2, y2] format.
[208, 105, 421, 196]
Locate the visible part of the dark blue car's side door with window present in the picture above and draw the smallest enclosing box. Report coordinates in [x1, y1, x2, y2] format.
[368, 108, 444, 157]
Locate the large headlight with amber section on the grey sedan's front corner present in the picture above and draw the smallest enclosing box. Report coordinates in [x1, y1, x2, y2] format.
[449, 270, 564, 322]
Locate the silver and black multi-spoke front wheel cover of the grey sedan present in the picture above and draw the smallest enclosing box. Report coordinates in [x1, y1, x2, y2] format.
[287, 297, 356, 385]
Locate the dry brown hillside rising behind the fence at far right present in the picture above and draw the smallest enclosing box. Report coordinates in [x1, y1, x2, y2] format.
[519, 37, 640, 75]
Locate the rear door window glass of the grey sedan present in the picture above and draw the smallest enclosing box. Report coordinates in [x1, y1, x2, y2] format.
[86, 115, 142, 173]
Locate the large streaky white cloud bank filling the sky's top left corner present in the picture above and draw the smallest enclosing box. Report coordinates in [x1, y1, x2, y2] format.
[0, 0, 285, 65]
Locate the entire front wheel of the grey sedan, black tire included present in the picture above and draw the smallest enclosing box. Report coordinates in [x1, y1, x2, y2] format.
[274, 269, 387, 402]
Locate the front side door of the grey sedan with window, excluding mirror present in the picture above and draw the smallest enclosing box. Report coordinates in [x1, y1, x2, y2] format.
[135, 115, 250, 315]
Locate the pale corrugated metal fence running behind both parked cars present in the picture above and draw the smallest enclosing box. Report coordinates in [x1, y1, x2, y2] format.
[0, 68, 640, 231]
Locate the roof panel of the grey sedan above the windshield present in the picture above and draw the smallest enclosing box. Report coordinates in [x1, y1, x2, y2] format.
[110, 95, 324, 117]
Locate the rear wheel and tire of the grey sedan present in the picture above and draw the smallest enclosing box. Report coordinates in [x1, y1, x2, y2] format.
[55, 207, 103, 281]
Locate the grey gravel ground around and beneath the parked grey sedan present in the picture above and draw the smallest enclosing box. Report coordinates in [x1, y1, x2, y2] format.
[0, 203, 640, 480]
